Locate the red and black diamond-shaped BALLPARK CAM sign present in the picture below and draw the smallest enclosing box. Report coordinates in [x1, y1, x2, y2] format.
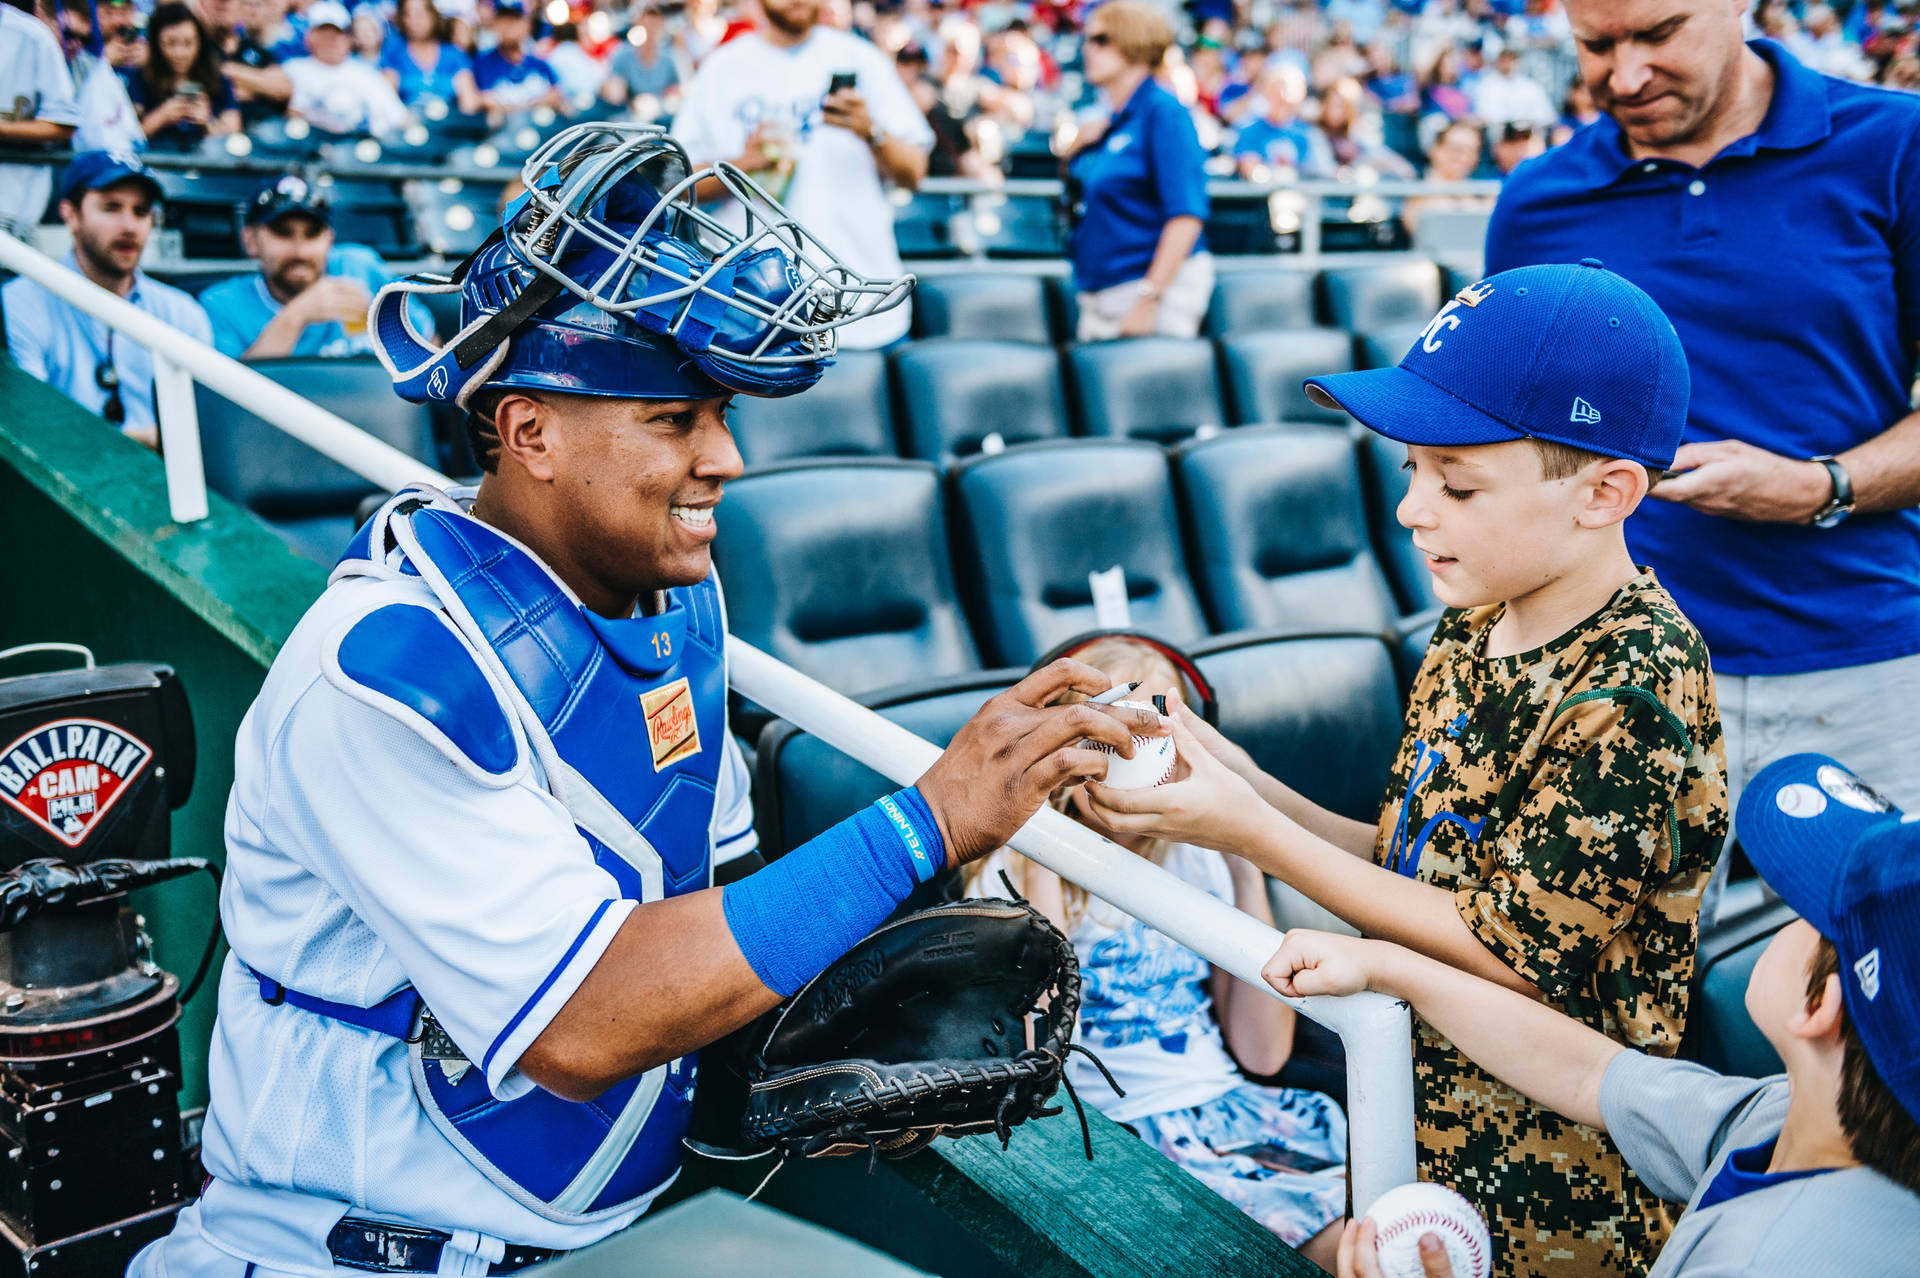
[0, 720, 154, 848]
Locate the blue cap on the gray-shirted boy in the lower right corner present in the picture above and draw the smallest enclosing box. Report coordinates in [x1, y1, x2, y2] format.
[1736, 754, 1920, 1121]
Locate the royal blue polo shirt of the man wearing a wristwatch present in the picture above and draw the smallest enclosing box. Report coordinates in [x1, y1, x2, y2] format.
[1486, 40, 1920, 675]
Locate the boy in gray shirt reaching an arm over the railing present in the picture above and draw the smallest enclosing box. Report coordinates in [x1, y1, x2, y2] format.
[1265, 754, 1920, 1278]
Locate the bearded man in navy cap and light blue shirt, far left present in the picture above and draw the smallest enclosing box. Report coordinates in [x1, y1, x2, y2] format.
[0, 154, 213, 449]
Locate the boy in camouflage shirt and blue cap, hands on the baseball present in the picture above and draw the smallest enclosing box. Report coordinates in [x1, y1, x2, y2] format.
[1089, 263, 1728, 1276]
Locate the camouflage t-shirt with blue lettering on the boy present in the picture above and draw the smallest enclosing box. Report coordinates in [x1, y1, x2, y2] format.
[1375, 570, 1728, 1278]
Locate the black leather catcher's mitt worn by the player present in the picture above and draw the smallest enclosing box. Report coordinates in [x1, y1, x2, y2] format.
[741, 900, 1104, 1159]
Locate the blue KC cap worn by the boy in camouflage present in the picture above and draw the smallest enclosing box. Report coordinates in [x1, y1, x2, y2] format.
[1306, 257, 1690, 470]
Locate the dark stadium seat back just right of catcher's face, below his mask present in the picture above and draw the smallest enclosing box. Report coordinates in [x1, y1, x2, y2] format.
[728, 351, 899, 466]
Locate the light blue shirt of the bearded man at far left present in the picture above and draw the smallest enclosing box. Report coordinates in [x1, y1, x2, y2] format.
[0, 253, 213, 430]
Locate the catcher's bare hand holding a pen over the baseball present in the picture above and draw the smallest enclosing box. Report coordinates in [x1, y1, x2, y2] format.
[918, 658, 1165, 865]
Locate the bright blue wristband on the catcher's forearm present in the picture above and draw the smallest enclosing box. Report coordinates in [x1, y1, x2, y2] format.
[720, 775, 947, 996]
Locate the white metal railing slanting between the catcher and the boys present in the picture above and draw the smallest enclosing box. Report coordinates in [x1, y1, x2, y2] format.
[0, 232, 1415, 1209]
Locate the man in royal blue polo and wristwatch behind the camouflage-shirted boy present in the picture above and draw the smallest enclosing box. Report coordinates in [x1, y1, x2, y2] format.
[1486, 0, 1920, 890]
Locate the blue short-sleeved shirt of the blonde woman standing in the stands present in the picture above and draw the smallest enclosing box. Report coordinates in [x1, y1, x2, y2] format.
[1071, 81, 1208, 292]
